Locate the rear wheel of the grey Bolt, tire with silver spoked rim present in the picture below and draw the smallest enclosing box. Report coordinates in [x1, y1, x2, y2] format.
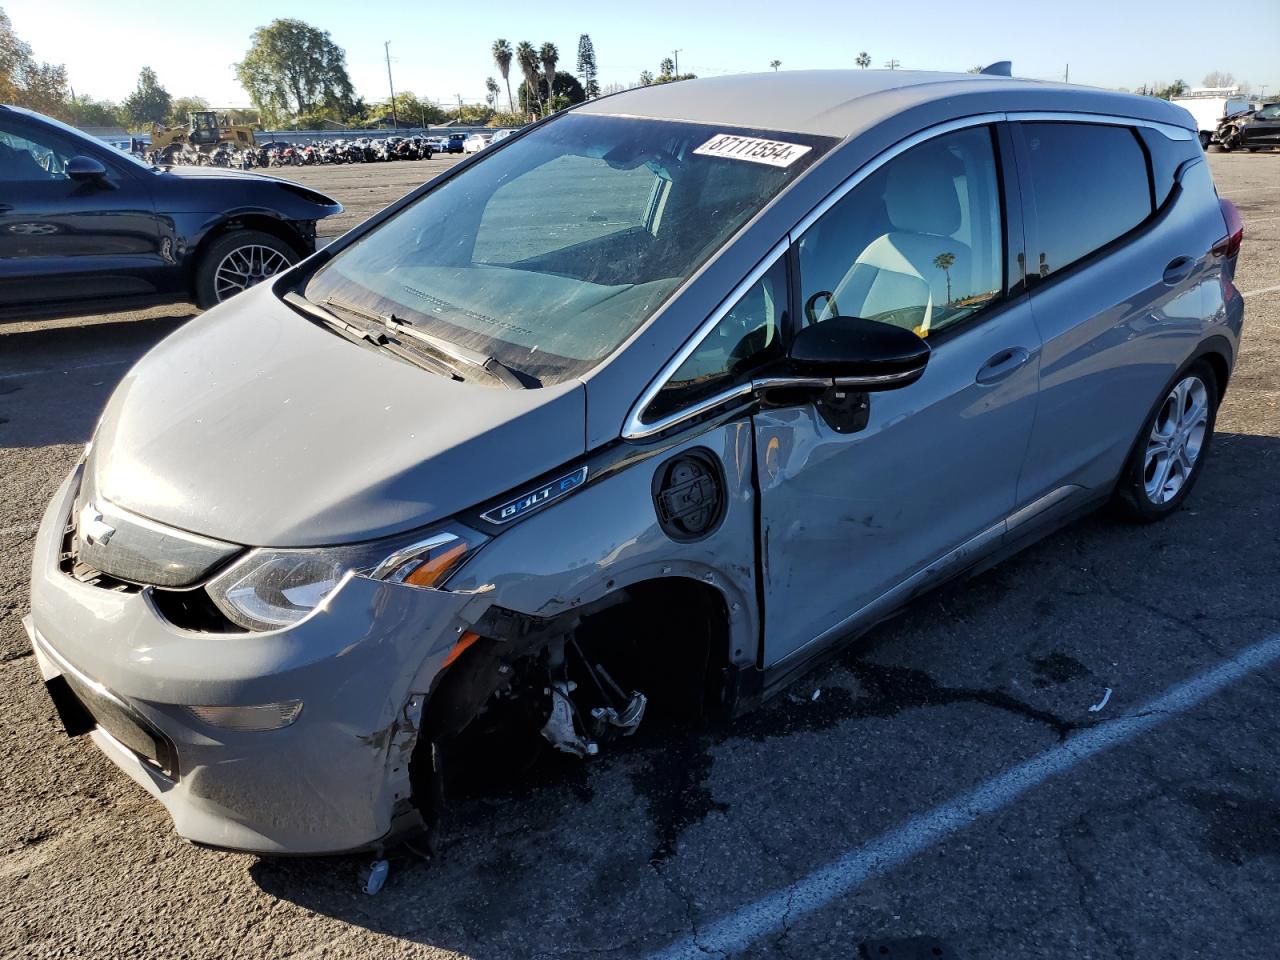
[1114, 360, 1221, 524]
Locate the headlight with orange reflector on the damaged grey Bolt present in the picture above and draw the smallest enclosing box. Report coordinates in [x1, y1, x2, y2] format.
[206, 526, 488, 630]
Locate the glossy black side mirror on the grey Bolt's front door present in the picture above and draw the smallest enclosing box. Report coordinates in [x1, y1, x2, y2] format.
[788, 316, 929, 390]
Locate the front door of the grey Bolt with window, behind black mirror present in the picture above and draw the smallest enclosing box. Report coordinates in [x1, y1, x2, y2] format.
[754, 127, 1041, 667]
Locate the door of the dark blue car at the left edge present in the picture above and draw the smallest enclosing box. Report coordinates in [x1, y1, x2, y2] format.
[0, 113, 172, 307]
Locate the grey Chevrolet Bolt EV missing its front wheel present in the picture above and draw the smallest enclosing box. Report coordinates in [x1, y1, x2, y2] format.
[27, 70, 1243, 852]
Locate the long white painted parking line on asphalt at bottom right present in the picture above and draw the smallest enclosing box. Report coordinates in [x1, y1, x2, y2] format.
[652, 634, 1280, 960]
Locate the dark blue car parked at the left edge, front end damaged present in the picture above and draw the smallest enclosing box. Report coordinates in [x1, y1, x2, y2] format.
[0, 106, 342, 316]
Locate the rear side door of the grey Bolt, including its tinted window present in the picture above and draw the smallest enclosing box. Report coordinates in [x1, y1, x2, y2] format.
[1011, 115, 1222, 504]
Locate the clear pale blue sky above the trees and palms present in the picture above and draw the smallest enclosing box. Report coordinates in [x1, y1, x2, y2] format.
[0, 0, 1280, 106]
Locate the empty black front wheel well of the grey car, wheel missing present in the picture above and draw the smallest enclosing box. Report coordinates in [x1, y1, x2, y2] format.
[410, 577, 730, 826]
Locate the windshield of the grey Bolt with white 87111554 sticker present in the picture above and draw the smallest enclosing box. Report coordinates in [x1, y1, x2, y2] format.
[305, 114, 832, 384]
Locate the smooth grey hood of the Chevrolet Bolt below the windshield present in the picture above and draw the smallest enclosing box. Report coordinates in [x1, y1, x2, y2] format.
[88, 284, 586, 547]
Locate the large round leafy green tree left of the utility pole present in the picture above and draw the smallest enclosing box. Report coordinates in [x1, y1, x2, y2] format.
[236, 19, 355, 124]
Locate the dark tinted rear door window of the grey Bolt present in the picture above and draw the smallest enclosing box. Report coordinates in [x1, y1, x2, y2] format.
[1021, 123, 1152, 276]
